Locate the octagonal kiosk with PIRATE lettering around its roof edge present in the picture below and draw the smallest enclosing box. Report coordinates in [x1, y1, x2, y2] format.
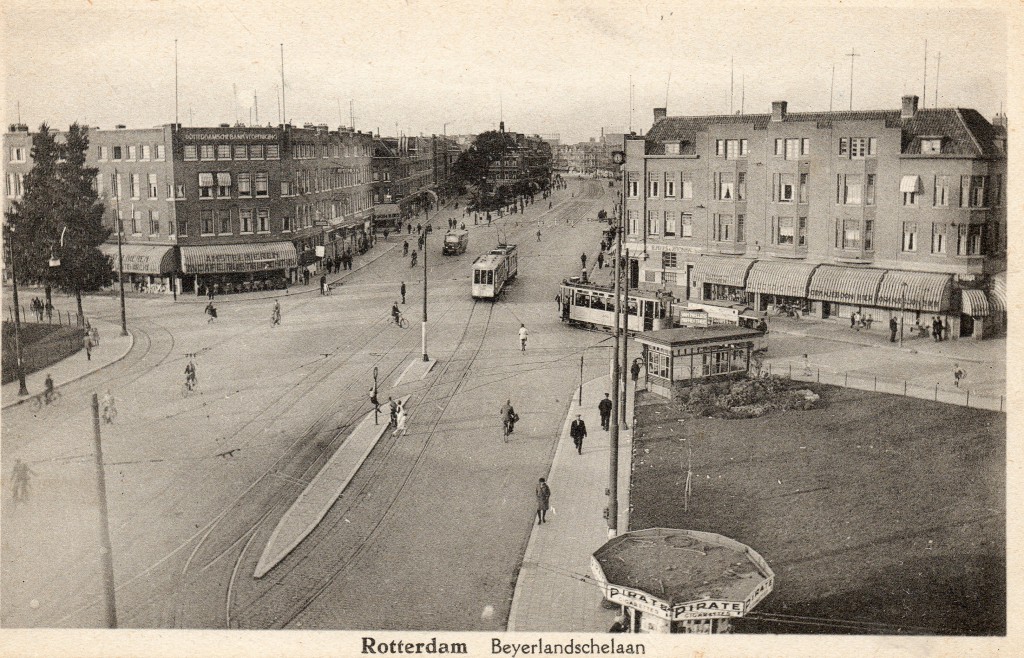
[591, 528, 775, 633]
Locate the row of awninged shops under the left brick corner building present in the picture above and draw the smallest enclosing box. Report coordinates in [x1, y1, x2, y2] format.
[100, 221, 373, 295]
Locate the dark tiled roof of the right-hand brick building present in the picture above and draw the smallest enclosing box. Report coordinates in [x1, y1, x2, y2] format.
[645, 107, 1004, 158]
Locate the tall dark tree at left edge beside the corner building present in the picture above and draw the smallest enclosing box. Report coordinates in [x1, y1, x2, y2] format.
[7, 123, 112, 318]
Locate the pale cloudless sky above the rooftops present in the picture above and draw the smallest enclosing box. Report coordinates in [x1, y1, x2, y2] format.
[0, 0, 1008, 142]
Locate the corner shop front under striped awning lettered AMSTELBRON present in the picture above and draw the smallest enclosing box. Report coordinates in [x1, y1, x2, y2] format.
[181, 242, 298, 295]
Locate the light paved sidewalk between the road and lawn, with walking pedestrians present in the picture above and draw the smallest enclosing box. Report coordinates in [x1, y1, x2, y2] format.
[508, 377, 633, 632]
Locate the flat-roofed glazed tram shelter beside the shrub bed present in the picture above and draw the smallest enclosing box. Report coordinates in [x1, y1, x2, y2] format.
[636, 324, 764, 399]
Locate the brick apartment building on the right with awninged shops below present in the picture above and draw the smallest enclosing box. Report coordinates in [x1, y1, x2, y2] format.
[623, 96, 1007, 338]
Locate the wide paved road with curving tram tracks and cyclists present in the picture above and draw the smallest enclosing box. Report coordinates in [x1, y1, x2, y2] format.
[0, 178, 610, 629]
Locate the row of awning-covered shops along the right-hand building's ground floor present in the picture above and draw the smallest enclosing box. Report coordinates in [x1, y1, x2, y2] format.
[689, 256, 1007, 339]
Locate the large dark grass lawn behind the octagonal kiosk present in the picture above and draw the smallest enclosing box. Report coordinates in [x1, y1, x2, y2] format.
[630, 386, 1007, 634]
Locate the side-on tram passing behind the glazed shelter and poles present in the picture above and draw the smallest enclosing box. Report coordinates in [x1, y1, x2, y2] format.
[558, 276, 672, 332]
